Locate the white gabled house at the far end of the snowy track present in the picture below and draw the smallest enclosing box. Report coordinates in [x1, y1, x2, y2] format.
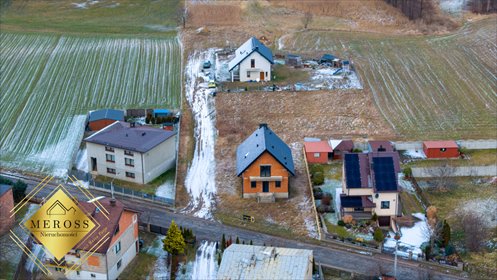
[228, 37, 274, 82]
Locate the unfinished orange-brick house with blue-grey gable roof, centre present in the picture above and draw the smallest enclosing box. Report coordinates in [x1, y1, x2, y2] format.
[236, 124, 295, 201]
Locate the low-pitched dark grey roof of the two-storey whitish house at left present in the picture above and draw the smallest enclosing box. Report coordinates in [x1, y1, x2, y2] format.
[84, 122, 176, 153]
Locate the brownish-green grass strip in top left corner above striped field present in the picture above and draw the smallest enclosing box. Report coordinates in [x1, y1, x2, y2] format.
[0, 0, 181, 36]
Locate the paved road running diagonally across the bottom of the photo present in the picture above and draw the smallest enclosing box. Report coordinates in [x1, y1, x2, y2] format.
[5, 173, 463, 279]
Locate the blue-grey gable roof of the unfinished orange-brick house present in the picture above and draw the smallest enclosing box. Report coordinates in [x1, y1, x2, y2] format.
[236, 124, 295, 176]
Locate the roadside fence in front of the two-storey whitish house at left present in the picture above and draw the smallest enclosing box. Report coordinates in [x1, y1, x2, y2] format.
[69, 170, 174, 207]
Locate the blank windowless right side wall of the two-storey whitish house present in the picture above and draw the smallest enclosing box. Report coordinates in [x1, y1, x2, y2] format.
[143, 134, 178, 184]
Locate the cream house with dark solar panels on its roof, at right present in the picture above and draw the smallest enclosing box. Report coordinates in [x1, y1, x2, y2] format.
[340, 152, 401, 227]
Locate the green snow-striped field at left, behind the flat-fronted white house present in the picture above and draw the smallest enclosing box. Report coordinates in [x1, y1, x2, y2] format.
[0, 33, 181, 174]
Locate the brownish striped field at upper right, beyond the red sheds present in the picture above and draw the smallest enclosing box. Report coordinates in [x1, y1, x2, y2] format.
[283, 18, 497, 139]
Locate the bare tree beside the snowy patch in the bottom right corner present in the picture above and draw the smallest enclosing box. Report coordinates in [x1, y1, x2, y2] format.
[460, 212, 489, 252]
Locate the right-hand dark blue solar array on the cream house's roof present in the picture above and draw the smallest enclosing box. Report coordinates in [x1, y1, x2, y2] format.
[373, 157, 397, 191]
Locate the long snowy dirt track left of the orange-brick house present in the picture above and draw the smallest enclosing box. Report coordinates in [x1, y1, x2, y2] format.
[185, 49, 217, 219]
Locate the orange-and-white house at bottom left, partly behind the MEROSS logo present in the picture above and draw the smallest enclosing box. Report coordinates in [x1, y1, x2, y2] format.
[44, 198, 139, 280]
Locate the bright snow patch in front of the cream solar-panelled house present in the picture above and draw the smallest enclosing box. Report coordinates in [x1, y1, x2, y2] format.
[383, 213, 430, 259]
